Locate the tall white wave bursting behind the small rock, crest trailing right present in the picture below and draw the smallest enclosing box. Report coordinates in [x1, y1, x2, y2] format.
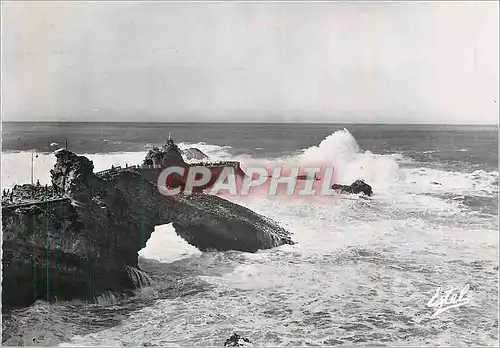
[278, 129, 499, 196]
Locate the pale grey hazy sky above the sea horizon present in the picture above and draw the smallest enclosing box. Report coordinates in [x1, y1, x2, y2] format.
[1, 1, 499, 124]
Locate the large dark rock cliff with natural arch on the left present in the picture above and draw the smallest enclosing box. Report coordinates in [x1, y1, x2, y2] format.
[2, 150, 293, 307]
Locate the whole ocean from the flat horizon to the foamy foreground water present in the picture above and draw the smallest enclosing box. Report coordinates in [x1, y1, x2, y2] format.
[2, 123, 499, 346]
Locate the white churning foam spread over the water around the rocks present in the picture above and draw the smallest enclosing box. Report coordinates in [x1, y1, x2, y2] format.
[2, 130, 498, 346]
